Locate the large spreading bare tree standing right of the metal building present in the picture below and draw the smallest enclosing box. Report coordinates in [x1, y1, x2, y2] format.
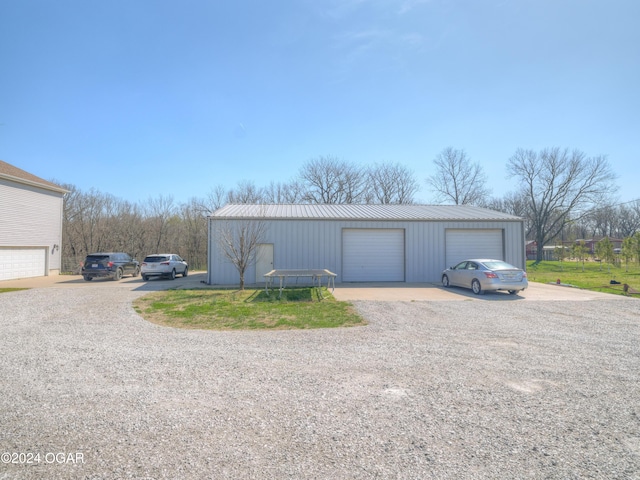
[507, 148, 615, 261]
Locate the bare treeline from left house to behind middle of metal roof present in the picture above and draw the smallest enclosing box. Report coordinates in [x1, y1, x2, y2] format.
[56, 157, 419, 272]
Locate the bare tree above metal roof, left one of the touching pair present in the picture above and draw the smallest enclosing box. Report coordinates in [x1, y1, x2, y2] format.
[300, 156, 367, 204]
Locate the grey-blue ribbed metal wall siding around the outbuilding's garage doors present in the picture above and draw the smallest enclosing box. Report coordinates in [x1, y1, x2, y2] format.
[209, 217, 525, 285]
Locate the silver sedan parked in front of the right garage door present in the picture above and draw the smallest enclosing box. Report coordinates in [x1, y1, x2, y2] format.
[442, 259, 529, 295]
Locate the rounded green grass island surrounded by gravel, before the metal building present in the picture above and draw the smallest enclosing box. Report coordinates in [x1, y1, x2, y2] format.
[134, 288, 367, 330]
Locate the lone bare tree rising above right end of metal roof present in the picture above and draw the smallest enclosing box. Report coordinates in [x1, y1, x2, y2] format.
[427, 147, 490, 205]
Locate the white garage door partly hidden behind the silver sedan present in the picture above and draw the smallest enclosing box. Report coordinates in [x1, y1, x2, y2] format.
[446, 229, 504, 267]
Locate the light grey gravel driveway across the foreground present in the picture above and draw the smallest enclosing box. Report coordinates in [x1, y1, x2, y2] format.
[0, 282, 640, 480]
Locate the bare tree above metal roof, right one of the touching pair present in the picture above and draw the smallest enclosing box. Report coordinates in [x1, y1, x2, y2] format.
[366, 163, 420, 204]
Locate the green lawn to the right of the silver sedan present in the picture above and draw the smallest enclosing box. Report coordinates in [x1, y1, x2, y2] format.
[527, 261, 640, 295]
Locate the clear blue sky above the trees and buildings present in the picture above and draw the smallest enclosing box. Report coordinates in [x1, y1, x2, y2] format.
[0, 0, 640, 202]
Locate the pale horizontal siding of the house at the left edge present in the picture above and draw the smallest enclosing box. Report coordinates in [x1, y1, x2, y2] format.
[0, 179, 63, 270]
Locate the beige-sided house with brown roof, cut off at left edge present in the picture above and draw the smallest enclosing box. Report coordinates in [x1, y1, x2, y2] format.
[0, 160, 67, 281]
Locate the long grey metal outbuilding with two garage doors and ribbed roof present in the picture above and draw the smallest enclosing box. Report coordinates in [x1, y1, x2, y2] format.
[208, 205, 526, 284]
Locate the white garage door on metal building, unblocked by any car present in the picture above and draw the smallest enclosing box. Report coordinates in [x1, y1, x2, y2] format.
[342, 228, 404, 282]
